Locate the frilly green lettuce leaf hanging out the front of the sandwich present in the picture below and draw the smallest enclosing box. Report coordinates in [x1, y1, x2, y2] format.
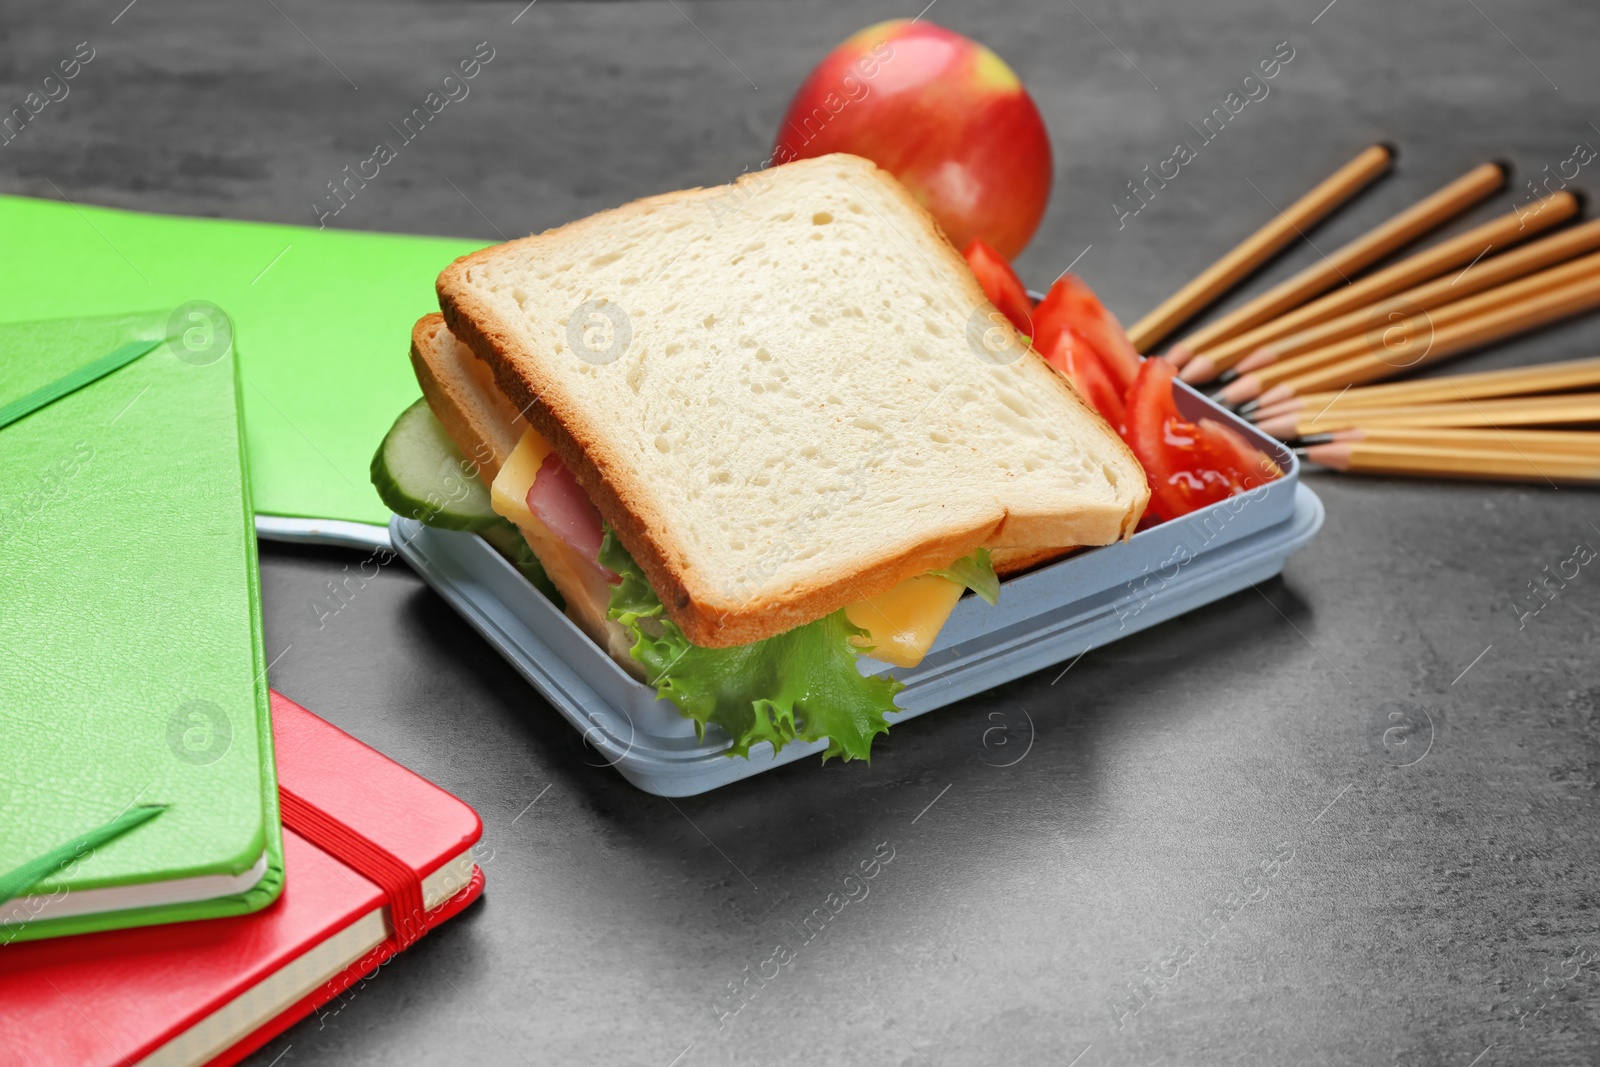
[600, 528, 906, 763]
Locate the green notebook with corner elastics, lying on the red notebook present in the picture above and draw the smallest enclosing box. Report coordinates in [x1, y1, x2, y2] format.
[0, 309, 283, 955]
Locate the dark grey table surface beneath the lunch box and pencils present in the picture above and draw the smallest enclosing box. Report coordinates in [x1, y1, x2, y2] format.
[0, 0, 1600, 1067]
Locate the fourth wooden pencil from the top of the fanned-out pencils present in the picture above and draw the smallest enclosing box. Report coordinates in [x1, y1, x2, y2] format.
[1227, 219, 1600, 395]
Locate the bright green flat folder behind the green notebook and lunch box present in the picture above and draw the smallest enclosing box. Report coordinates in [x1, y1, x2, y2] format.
[0, 197, 483, 523]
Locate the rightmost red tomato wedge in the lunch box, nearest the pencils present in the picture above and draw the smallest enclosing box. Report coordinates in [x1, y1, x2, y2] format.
[1123, 360, 1283, 518]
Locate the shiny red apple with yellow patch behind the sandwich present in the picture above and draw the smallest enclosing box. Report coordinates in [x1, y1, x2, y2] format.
[773, 19, 1051, 259]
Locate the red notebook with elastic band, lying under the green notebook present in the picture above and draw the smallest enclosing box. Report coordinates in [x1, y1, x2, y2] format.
[0, 693, 483, 1067]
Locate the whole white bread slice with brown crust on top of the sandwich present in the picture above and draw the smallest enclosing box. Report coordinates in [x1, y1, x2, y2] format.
[438, 155, 1149, 648]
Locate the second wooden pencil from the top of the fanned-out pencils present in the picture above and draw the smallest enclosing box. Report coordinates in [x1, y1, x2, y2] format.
[1182, 163, 1506, 352]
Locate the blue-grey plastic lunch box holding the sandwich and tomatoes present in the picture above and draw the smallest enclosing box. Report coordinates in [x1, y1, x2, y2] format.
[389, 382, 1323, 797]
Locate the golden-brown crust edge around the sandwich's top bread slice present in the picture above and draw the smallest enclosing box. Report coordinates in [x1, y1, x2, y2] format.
[437, 157, 1149, 648]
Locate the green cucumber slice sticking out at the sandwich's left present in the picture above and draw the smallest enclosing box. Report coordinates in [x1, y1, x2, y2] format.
[373, 400, 501, 530]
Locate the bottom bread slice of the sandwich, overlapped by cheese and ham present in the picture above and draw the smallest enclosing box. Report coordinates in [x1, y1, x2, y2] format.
[411, 314, 645, 678]
